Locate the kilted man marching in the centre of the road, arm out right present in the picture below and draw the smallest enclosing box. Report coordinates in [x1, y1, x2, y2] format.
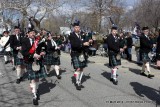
[69, 21, 89, 90]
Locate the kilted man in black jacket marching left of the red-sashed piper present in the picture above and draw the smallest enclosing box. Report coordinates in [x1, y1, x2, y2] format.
[4, 26, 25, 84]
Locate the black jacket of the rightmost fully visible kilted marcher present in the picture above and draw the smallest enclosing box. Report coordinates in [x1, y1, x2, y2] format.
[140, 34, 153, 53]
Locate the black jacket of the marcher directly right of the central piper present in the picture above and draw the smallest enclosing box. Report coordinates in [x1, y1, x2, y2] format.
[107, 34, 120, 53]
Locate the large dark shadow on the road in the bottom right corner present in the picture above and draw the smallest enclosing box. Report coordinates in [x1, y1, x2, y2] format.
[130, 82, 160, 105]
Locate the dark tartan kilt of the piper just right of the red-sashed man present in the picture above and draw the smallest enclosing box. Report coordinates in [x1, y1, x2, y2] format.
[43, 53, 60, 65]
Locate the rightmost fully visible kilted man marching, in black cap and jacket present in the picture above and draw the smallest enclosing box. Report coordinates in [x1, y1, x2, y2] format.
[140, 27, 154, 78]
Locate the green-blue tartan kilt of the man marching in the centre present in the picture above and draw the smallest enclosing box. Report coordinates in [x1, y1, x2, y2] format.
[71, 56, 87, 69]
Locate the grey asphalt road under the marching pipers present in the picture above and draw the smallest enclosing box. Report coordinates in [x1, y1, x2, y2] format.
[0, 49, 160, 107]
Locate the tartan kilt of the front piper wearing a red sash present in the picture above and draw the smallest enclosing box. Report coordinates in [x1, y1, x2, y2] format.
[26, 63, 47, 80]
